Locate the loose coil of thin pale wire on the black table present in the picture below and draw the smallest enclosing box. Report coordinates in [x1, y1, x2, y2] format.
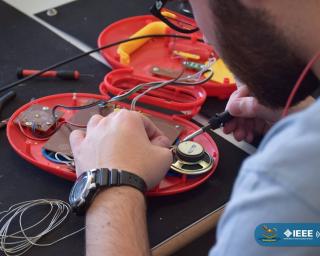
[0, 199, 84, 256]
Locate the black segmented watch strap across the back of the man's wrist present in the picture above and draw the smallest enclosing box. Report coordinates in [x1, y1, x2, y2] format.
[96, 168, 147, 194]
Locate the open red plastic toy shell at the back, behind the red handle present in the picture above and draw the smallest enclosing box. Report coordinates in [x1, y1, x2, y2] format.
[98, 15, 236, 99]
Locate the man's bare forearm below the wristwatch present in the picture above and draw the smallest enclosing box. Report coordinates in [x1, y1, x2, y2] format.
[86, 187, 150, 256]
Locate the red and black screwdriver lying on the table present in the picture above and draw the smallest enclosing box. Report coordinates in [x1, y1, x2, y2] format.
[17, 68, 93, 80]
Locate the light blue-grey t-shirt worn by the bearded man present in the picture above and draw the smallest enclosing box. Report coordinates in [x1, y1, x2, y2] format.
[210, 100, 320, 256]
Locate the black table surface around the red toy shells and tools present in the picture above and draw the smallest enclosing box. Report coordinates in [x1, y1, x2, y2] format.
[0, 1, 247, 255]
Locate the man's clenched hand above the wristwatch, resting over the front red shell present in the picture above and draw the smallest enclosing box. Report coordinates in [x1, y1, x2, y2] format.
[70, 110, 172, 189]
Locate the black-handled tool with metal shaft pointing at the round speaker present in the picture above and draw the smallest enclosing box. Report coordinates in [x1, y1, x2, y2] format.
[182, 111, 233, 142]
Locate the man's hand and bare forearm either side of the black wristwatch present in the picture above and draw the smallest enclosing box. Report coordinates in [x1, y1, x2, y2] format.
[70, 110, 172, 256]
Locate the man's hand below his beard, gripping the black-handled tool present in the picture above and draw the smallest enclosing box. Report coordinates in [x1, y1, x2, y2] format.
[223, 85, 314, 143]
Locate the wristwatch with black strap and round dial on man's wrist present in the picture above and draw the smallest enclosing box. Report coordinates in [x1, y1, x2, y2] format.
[69, 168, 147, 215]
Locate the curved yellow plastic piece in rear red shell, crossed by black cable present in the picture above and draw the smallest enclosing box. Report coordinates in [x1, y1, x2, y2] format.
[117, 21, 168, 65]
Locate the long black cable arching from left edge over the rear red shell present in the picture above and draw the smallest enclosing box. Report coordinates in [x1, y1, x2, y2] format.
[0, 34, 203, 92]
